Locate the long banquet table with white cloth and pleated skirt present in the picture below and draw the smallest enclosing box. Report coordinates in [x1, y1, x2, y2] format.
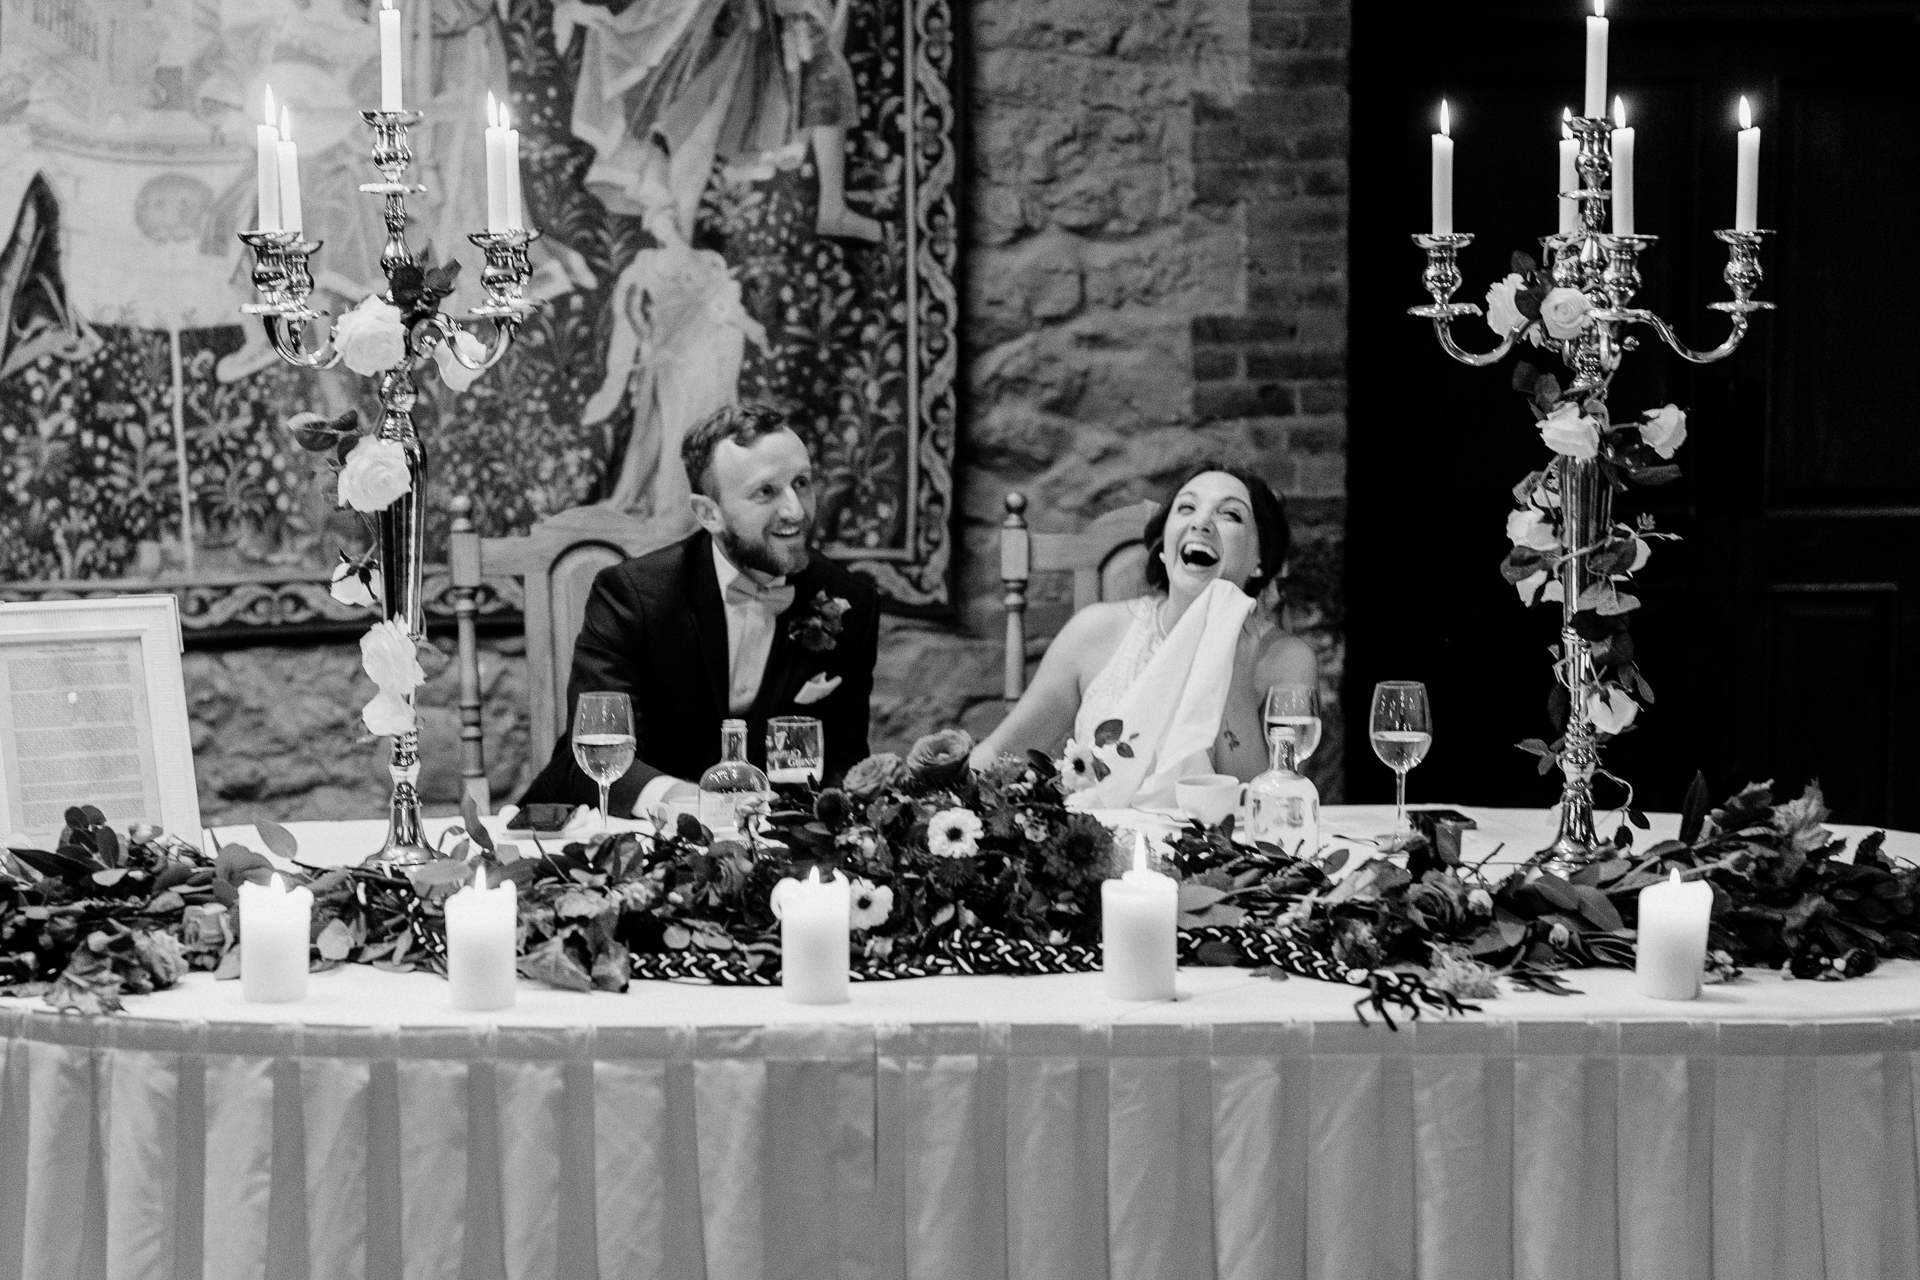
[0, 810, 1920, 1280]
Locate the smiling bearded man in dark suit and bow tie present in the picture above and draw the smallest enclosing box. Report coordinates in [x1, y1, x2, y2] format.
[520, 405, 879, 814]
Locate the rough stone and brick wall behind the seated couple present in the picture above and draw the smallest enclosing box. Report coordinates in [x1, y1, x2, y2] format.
[186, 0, 1350, 819]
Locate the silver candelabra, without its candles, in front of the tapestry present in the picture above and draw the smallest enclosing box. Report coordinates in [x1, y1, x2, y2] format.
[240, 111, 540, 864]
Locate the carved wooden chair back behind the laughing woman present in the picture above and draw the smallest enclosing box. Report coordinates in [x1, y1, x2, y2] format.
[1000, 491, 1160, 702]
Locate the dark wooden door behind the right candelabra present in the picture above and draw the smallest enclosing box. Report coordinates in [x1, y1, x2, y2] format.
[1346, 0, 1920, 827]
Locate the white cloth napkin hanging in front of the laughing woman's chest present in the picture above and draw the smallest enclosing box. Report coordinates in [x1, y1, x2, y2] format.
[1073, 580, 1254, 808]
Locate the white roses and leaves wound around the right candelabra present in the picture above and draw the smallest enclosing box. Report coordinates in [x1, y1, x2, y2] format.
[1486, 253, 1686, 781]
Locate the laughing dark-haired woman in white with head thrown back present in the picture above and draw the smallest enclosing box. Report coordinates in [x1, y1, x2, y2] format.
[973, 464, 1317, 781]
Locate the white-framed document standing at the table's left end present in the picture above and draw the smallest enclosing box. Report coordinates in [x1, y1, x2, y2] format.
[0, 595, 200, 848]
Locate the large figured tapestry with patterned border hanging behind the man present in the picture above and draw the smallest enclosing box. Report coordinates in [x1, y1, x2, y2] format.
[0, 0, 956, 606]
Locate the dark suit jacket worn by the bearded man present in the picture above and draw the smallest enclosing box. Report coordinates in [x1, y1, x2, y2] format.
[520, 532, 879, 814]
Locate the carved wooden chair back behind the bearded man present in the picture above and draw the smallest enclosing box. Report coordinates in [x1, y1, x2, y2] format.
[447, 497, 693, 814]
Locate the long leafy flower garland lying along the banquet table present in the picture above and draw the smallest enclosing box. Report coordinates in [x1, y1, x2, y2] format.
[0, 731, 1920, 1021]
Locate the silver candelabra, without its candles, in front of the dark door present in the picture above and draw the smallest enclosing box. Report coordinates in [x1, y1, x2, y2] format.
[1407, 117, 1774, 864]
